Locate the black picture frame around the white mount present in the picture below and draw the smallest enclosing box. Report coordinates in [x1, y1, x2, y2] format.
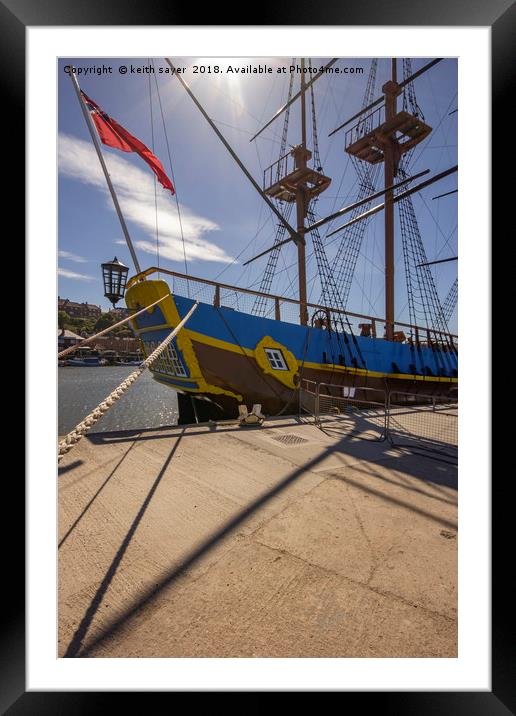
[8, 0, 516, 716]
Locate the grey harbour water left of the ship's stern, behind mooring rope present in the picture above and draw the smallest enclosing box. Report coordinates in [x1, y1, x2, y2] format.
[58, 366, 178, 435]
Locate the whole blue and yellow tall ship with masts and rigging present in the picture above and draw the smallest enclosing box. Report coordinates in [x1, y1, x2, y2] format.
[66, 58, 458, 422]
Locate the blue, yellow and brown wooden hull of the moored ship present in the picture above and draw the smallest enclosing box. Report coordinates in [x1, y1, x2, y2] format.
[126, 280, 458, 417]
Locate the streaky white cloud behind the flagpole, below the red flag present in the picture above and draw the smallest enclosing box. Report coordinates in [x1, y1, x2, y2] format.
[59, 134, 233, 263]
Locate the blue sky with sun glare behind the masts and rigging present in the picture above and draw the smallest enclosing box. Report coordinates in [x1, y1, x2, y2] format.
[58, 58, 457, 330]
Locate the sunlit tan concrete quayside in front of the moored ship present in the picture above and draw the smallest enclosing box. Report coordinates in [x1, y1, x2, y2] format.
[59, 415, 457, 657]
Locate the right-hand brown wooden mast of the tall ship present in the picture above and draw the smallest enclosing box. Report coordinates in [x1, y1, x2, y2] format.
[382, 58, 400, 341]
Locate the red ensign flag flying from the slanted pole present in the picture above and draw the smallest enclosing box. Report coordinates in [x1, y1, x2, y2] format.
[81, 90, 176, 194]
